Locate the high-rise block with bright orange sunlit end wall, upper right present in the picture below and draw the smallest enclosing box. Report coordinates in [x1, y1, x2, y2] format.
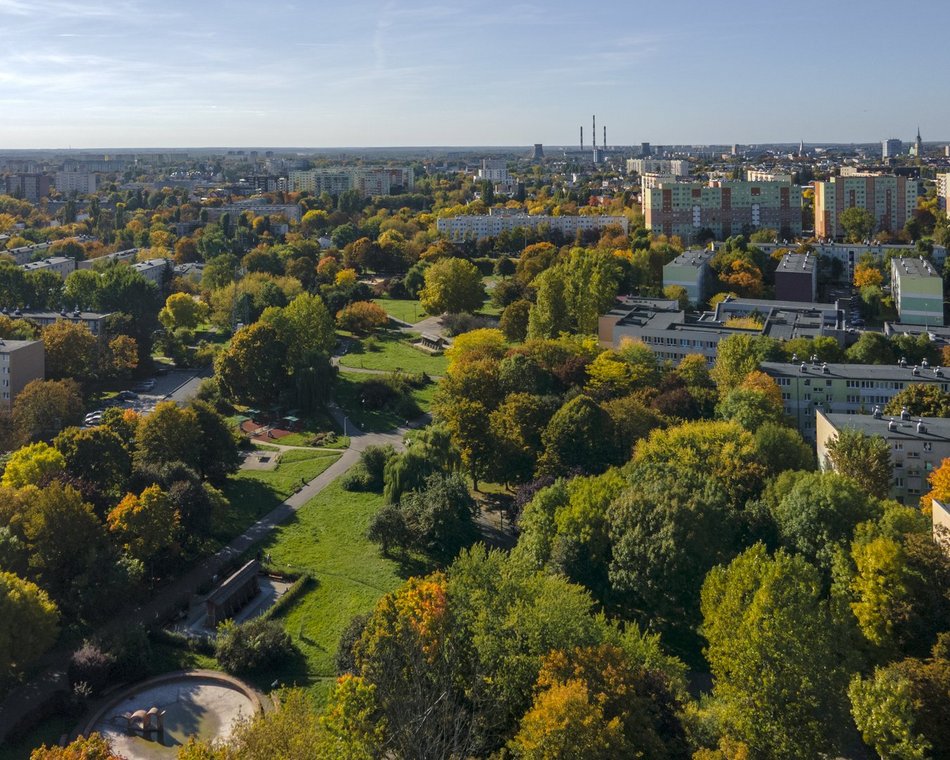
[815, 174, 919, 240]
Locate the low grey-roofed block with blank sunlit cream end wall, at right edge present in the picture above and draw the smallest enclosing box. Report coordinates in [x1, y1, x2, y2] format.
[815, 410, 950, 506]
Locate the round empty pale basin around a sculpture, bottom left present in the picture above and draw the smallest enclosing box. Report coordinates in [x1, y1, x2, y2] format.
[84, 671, 260, 760]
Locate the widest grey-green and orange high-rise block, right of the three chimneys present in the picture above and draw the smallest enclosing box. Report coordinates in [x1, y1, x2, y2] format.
[643, 180, 802, 241]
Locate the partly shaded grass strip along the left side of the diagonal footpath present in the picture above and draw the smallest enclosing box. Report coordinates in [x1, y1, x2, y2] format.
[214, 450, 339, 543]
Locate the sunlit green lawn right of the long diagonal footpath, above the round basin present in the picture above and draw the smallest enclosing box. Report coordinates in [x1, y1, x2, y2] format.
[256, 480, 425, 701]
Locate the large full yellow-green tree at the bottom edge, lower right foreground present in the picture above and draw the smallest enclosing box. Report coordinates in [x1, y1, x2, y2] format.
[702, 544, 846, 758]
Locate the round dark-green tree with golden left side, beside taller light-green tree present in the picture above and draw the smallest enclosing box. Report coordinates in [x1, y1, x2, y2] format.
[215, 322, 287, 404]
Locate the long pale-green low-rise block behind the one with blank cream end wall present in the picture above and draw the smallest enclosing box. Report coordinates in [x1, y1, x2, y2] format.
[760, 357, 950, 441]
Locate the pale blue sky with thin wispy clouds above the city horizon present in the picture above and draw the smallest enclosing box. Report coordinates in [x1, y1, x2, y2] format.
[0, 0, 950, 150]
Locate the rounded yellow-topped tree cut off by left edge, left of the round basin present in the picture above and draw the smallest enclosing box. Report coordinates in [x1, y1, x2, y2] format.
[0, 571, 59, 677]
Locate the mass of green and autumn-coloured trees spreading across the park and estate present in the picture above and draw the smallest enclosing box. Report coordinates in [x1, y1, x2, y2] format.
[0, 163, 950, 760]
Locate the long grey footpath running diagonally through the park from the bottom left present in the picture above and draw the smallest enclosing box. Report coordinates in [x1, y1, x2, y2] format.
[0, 407, 416, 742]
